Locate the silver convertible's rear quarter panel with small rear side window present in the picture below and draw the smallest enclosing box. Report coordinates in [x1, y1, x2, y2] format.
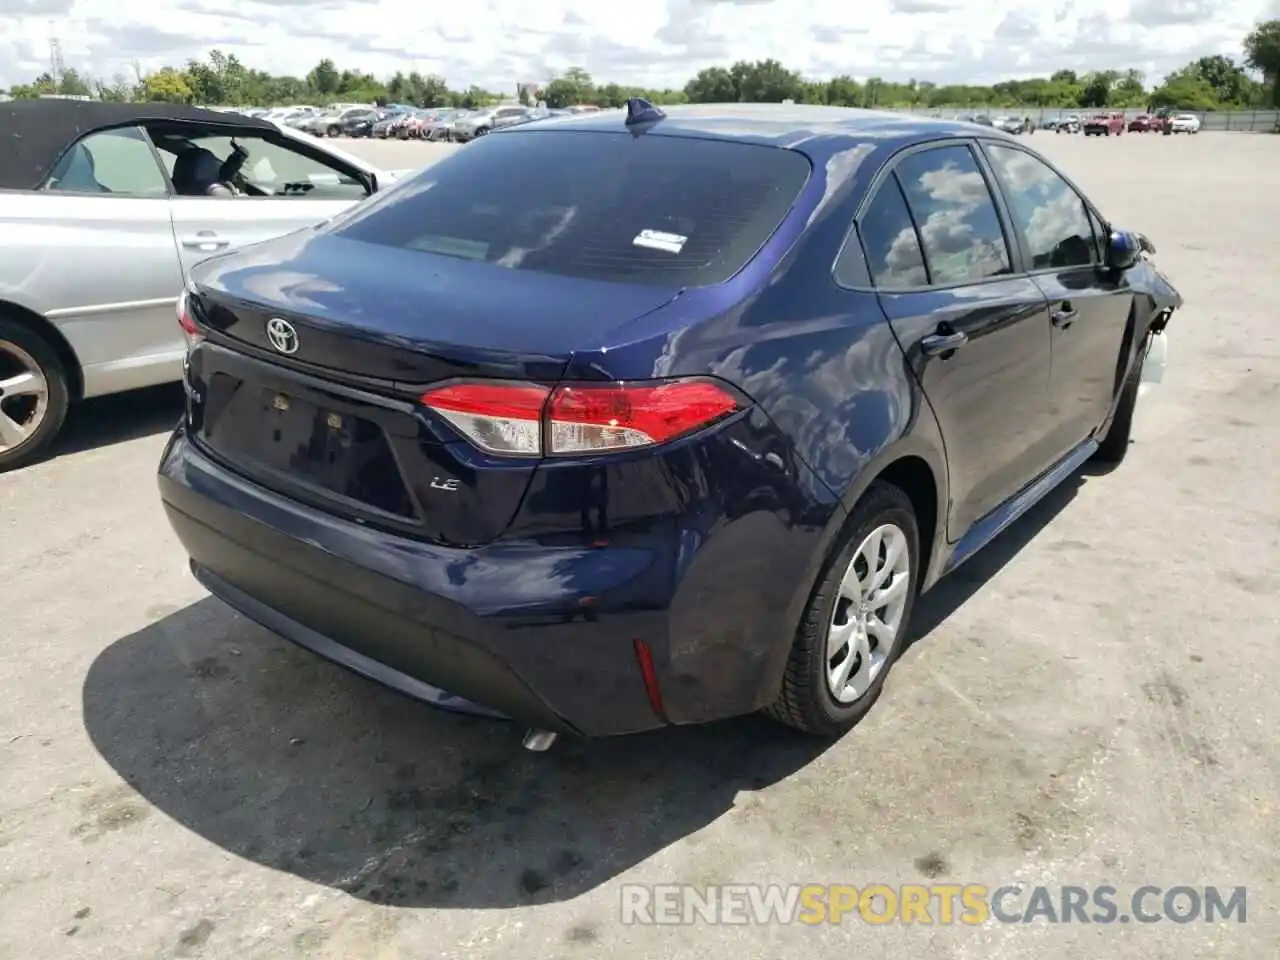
[9, 128, 184, 397]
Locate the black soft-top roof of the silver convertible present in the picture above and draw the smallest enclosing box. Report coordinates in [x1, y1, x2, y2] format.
[0, 100, 279, 189]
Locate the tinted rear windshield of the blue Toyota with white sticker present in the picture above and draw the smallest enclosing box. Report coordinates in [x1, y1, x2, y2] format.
[330, 131, 810, 287]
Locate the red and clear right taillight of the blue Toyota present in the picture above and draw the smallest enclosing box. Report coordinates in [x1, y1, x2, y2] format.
[421, 379, 739, 457]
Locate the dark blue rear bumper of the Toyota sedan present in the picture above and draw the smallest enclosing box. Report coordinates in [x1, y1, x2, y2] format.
[159, 426, 815, 736]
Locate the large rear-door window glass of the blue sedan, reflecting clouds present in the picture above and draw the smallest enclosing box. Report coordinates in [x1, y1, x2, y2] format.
[896, 146, 1010, 285]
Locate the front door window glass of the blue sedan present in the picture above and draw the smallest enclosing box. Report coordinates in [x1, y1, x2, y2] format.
[987, 143, 1098, 270]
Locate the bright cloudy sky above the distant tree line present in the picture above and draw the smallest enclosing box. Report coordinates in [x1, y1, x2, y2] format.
[0, 0, 1264, 90]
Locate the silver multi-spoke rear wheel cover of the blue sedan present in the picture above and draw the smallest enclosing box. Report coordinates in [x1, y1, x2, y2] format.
[827, 524, 911, 705]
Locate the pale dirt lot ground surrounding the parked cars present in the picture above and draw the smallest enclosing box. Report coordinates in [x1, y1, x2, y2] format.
[0, 133, 1280, 960]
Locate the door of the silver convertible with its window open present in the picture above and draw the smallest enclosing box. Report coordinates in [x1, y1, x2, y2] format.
[163, 129, 369, 271]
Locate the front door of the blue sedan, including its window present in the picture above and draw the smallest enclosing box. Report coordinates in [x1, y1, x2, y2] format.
[983, 142, 1133, 453]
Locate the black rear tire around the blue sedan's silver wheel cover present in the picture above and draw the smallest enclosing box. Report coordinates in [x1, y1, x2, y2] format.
[764, 481, 920, 737]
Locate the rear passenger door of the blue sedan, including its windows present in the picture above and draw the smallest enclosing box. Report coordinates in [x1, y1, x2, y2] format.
[858, 142, 1053, 540]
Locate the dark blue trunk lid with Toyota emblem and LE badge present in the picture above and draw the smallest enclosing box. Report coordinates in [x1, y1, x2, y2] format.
[188, 232, 677, 547]
